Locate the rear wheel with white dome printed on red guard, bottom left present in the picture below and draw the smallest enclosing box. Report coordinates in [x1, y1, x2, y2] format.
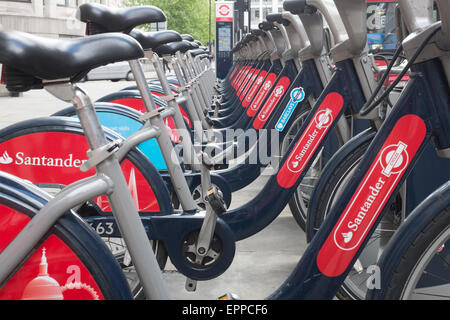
[0, 173, 132, 300]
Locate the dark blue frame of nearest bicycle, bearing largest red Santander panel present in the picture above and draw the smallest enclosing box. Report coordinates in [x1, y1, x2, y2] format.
[270, 59, 450, 299]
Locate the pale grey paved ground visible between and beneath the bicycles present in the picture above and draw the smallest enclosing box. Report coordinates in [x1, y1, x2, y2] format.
[0, 81, 305, 299]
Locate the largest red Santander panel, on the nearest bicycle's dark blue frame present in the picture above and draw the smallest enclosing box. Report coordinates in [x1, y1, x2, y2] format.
[317, 114, 427, 277]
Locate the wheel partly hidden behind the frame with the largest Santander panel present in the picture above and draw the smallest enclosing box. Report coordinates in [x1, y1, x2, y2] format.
[307, 131, 402, 300]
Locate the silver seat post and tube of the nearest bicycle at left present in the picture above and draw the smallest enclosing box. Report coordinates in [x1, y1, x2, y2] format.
[44, 82, 169, 299]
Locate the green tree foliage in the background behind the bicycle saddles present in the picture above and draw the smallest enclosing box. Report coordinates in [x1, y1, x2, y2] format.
[124, 0, 214, 45]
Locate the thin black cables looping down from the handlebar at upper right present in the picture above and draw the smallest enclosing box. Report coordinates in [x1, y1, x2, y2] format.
[360, 27, 442, 116]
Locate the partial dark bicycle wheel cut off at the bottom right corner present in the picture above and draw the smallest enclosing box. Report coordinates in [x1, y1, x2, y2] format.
[368, 183, 450, 300]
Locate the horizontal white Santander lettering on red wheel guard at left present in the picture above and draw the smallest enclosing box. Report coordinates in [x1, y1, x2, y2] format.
[0, 150, 87, 168]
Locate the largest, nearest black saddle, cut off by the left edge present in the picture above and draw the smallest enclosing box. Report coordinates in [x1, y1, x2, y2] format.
[0, 30, 144, 91]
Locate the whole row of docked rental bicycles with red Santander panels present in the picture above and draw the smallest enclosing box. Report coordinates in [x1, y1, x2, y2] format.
[0, 0, 450, 300]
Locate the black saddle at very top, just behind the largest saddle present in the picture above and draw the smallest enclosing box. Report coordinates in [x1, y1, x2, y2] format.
[77, 3, 166, 35]
